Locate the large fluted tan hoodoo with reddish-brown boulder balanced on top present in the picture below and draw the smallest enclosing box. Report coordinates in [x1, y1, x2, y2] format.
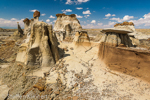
[16, 12, 59, 67]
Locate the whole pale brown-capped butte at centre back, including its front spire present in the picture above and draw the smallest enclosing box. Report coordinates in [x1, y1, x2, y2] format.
[54, 14, 82, 41]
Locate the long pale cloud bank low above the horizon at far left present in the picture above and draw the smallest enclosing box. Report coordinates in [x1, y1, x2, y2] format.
[0, 18, 24, 28]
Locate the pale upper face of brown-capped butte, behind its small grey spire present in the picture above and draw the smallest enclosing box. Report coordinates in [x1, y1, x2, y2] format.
[54, 14, 82, 31]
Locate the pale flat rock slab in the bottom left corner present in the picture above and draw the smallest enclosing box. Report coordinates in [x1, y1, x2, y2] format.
[0, 85, 9, 100]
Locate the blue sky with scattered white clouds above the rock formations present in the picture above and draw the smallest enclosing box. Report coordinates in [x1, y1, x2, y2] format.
[0, 0, 150, 28]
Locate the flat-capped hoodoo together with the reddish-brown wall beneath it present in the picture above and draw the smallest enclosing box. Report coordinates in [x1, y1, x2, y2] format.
[98, 29, 150, 81]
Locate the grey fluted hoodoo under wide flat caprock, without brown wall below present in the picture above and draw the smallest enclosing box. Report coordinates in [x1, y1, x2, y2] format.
[100, 29, 133, 47]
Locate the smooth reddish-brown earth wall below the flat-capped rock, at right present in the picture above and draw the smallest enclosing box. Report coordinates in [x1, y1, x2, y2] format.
[98, 42, 150, 82]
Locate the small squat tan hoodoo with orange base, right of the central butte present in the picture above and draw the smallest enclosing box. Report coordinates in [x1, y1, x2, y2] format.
[73, 31, 90, 46]
